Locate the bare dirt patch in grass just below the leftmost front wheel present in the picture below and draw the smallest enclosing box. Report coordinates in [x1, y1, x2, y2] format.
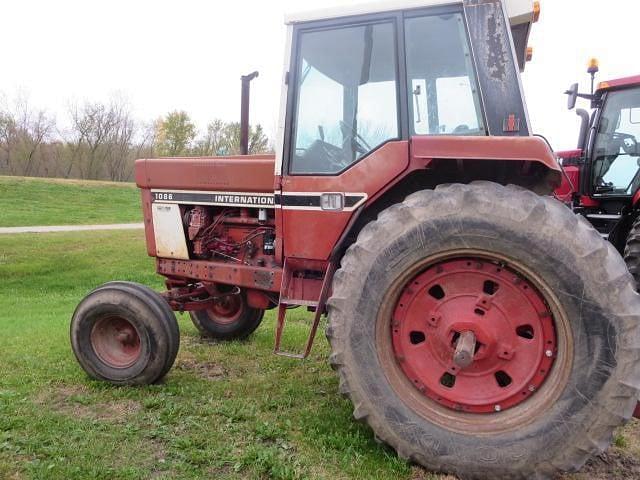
[35, 385, 142, 422]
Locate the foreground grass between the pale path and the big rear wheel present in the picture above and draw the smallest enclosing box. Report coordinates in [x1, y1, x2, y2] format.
[0, 231, 431, 479]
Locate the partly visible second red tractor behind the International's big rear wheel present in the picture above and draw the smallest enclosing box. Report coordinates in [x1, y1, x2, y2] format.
[556, 59, 640, 253]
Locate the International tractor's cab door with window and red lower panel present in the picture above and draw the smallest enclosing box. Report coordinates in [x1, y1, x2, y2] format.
[277, 14, 408, 261]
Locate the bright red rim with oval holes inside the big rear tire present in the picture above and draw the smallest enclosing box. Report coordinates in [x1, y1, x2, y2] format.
[391, 258, 557, 413]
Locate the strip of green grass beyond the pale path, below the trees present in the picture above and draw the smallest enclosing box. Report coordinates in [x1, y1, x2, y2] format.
[0, 177, 142, 227]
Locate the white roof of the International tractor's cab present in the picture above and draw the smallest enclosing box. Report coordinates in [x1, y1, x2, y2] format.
[285, 0, 533, 25]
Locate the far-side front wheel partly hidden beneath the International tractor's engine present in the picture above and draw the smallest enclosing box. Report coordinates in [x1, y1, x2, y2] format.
[189, 291, 264, 340]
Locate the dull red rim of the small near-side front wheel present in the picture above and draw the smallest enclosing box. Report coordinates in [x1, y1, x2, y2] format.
[91, 317, 142, 368]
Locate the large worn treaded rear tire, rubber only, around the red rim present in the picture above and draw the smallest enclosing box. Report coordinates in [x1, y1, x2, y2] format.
[327, 182, 640, 479]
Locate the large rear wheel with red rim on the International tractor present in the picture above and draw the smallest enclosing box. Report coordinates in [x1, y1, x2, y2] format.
[327, 182, 640, 479]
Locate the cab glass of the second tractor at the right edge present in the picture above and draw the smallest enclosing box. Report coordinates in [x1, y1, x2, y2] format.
[592, 88, 640, 195]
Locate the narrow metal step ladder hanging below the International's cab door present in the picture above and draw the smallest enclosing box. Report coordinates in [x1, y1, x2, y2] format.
[273, 260, 335, 360]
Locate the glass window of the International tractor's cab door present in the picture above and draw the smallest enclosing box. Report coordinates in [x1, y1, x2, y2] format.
[290, 22, 398, 173]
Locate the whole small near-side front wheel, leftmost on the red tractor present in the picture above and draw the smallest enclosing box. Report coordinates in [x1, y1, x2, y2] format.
[71, 282, 180, 385]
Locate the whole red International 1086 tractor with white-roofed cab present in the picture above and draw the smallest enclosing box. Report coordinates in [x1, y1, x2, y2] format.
[71, 0, 640, 479]
